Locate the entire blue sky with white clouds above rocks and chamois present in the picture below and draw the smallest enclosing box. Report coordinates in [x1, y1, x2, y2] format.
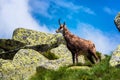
[0, 0, 120, 54]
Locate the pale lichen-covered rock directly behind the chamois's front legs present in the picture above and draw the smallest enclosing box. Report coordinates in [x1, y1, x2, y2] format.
[39, 44, 85, 70]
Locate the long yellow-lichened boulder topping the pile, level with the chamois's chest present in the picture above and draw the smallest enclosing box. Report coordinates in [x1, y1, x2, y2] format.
[12, 28, 65, 46]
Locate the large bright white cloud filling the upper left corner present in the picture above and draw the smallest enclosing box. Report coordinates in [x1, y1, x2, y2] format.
[0, 0, 50, 38]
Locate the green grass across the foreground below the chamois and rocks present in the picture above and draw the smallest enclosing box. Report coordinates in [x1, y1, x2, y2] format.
[30, 57, 120, 80]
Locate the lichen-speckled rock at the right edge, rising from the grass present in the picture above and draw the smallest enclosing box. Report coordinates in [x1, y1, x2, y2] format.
[109, 45, 120, 67]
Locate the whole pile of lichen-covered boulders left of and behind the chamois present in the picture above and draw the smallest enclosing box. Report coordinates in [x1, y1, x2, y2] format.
[0, 28, 101, 80]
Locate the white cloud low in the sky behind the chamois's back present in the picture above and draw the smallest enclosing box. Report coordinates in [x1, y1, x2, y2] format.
[77, 23, 120, 54]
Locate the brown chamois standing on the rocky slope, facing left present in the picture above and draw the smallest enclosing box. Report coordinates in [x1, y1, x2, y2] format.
[56, 19, 99, 64]
